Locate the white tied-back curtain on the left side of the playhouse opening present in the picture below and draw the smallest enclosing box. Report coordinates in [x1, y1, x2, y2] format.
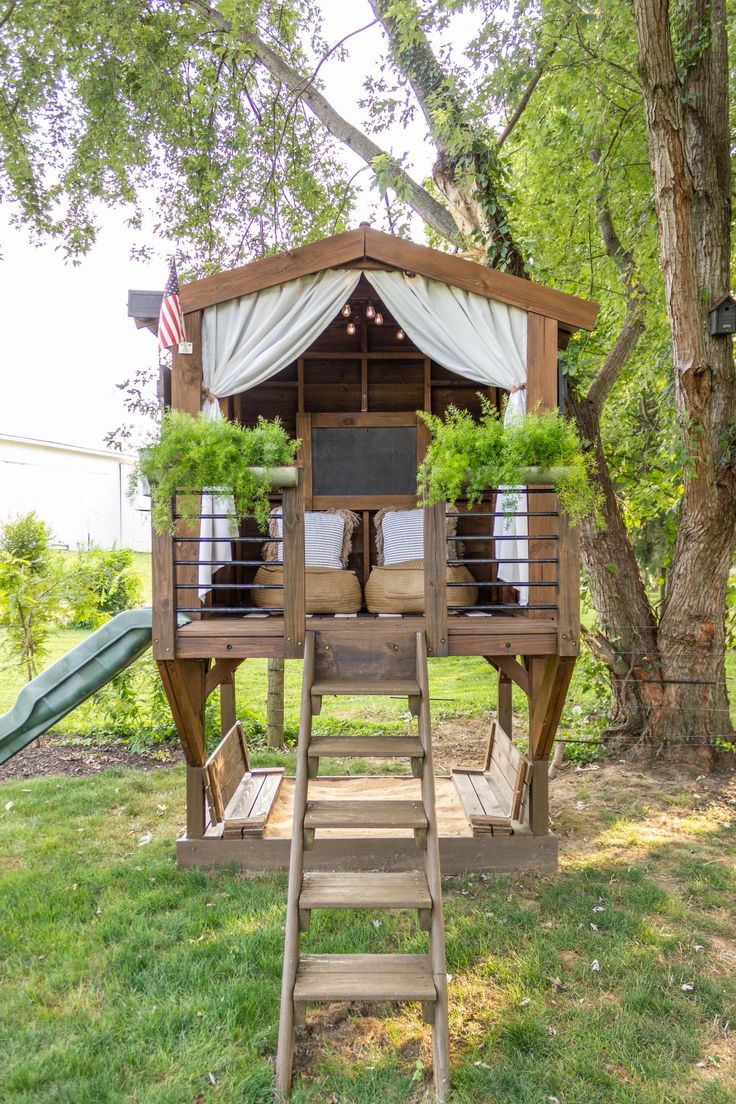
[198, 268, 361, 598]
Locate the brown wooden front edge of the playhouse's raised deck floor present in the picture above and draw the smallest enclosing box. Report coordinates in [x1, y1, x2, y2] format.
[177, 614, 558, 659]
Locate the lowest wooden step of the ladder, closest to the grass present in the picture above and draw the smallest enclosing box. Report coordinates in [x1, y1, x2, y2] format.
[294, 955, 437, 1002]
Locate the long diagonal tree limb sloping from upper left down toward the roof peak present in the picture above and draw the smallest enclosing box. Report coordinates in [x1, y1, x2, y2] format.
[181, 0, 461, 245]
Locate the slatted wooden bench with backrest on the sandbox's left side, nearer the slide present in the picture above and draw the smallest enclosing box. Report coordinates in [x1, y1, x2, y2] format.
[204, 721, 284, 839]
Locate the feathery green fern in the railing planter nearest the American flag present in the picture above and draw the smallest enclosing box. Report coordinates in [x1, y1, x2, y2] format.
[134, 411, 299, 533]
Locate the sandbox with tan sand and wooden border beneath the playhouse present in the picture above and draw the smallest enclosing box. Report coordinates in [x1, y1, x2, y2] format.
[177, 775, 557, 874]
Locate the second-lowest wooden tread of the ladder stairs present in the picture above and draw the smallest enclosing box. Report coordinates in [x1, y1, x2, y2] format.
[299, 870, 431, 909]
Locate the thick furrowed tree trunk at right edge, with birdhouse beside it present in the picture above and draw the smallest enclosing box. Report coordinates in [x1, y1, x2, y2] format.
[634, 0, 736, 759]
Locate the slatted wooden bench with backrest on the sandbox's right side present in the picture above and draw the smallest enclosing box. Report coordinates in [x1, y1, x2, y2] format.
[452, 721, 532, 836]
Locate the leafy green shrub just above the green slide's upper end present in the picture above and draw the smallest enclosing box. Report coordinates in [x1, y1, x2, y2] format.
[71, 549, 143, 628]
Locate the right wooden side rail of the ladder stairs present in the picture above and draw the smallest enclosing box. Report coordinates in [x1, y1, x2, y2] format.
[417, 633, 450, 1102]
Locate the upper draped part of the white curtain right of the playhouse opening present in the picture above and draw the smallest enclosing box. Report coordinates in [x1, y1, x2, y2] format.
[366, 270, 526, 391]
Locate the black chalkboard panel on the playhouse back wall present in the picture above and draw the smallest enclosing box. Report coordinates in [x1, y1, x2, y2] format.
[312, 425, 417, 498]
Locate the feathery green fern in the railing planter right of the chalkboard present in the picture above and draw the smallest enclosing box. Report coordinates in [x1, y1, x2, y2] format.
[418, 396, 601, 526]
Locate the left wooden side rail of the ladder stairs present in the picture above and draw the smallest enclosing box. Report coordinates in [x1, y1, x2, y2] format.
[276, 633, 314, 1101]
